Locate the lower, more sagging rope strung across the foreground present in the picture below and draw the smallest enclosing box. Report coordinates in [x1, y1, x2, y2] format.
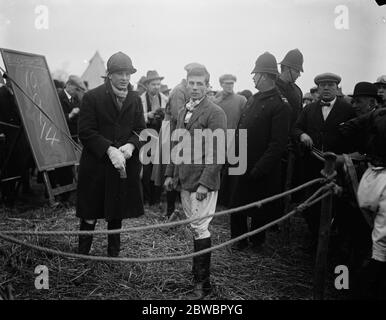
[0, 190, 333, 263]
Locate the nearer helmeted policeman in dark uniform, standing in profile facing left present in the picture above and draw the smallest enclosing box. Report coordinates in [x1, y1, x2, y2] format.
[230, 52, 291, 250]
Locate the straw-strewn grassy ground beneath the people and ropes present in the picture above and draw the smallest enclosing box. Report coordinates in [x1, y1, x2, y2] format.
[0, 189, 348, 300]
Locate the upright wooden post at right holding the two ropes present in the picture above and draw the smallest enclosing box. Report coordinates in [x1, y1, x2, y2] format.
[314, 152, 336, 300]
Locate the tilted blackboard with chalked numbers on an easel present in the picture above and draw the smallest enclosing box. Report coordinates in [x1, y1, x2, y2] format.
[0, 49, 78, 171]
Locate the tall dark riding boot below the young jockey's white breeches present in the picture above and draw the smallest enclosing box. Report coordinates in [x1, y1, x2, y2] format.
[188, 237, 212, 300]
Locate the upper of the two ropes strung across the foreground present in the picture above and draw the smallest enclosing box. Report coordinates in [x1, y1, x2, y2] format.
[0, 178, 331, 236]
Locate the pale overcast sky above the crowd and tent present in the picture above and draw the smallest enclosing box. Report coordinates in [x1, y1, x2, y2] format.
[0, 0, 386, 93]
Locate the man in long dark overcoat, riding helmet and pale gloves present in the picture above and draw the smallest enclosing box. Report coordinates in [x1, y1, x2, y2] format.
[76, 52, 146, 256]
